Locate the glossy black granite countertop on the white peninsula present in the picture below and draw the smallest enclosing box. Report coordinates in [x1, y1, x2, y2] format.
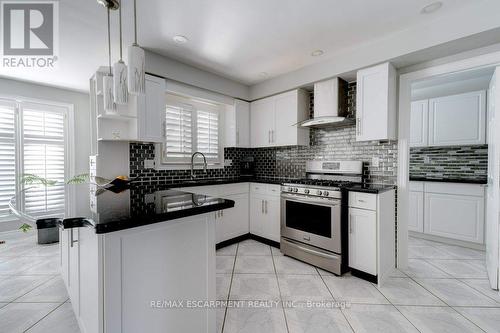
[11, 184, 234, 234]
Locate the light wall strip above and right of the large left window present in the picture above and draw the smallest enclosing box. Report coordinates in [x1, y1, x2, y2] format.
[0, 78, 90, 231]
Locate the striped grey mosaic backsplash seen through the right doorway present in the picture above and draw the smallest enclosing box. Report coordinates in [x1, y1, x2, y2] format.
[410, 145, 488, 180]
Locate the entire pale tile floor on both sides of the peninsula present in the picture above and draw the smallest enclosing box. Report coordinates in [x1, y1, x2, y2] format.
[0, 232, 500, 333]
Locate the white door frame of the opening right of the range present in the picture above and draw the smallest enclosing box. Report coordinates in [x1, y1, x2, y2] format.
[396, 52, 500, 269]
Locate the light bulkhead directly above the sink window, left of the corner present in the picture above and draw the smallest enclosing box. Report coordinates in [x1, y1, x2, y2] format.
[146, 51, 249, 100]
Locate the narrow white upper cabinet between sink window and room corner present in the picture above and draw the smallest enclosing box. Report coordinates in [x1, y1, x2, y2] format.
[225, 99, 250, 148]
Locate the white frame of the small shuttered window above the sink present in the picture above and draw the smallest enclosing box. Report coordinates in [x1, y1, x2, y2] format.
[155, 91, 225, 170]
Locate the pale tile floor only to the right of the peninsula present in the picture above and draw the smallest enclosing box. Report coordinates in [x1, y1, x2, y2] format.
[217, 238, 500, 333]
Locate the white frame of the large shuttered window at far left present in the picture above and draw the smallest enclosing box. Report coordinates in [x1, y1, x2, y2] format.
[0, 94, 76, 223]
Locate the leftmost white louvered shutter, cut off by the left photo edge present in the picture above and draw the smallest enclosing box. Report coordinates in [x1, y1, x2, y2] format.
[0, 100, 16, 218]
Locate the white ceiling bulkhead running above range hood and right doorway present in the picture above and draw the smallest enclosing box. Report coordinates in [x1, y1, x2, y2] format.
[250, 0, 500, 100]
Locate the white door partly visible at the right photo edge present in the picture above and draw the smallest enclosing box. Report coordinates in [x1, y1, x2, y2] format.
[486, 67, 500, 289]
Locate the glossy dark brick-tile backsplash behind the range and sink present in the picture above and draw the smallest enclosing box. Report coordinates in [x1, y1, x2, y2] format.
[130, 83, 397, 185]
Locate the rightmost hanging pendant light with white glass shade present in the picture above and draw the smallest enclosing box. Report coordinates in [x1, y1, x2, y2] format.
[128, 0, 146, 95]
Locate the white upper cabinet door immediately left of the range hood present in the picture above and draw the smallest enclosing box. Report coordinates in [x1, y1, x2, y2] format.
[271, 90, 297, 146]
